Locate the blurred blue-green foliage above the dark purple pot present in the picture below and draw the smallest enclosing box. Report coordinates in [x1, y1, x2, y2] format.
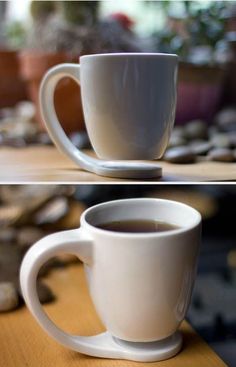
[147, 1, 231, 60]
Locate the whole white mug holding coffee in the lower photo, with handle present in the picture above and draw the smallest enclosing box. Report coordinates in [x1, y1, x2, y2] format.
[20, 199, 201, 361]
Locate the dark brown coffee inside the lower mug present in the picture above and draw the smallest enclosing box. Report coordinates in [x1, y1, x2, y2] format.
[97, 219, 179, 233]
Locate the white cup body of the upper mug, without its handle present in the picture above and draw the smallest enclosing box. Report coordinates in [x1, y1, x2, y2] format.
[80, 53, 178, 160]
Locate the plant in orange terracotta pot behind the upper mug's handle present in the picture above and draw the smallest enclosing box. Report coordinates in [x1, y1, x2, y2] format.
[20, 1, 89, 133]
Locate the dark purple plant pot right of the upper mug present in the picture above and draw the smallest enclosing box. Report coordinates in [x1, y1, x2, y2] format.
[176, 62, 225, 124]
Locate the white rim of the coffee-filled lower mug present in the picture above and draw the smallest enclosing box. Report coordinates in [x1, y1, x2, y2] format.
[80, 198, 202, 239]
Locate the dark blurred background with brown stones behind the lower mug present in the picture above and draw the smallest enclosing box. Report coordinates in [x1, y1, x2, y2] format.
[0, 185, 236, 366]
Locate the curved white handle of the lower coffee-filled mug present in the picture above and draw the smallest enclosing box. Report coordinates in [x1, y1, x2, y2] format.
[20, 229, 126, 358]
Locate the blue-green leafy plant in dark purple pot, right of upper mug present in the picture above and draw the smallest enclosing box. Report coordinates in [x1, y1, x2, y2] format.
[150, 1, 227, 123]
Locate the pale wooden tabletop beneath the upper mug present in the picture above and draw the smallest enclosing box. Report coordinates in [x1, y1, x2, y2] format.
[0, 146, 236, 183]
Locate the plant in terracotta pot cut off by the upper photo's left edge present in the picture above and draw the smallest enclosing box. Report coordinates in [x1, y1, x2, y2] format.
[0, 1, 26, 108]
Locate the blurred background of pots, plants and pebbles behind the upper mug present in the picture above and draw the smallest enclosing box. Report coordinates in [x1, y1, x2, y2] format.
[0, 0, 236, 163]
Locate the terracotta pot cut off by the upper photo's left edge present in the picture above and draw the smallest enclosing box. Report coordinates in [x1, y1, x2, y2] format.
[0, 49, 26, 108]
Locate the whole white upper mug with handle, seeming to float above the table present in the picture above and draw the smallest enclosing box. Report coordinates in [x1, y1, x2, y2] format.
[40, 53, 178, 177]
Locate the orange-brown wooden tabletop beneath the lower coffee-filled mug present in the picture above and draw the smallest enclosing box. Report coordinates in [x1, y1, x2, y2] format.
[0, 265, 226, 367]
